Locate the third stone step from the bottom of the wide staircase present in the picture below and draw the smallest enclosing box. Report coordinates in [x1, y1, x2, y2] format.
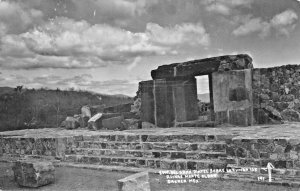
[77, 141, 226, 152]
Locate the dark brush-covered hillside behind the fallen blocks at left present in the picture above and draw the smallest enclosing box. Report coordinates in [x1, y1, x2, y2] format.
[0, 87, 133, 131]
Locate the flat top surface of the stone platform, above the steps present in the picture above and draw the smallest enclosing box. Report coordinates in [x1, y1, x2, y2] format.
[0, 122, 300, 141]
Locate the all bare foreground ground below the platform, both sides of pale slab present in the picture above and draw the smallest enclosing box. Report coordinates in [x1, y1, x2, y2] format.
[0, 163, 298, 191]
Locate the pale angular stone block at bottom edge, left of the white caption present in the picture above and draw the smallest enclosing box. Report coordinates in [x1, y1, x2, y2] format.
[117, 172, 151, 191]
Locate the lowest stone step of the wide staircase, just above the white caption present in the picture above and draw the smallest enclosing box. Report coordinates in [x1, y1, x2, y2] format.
[64, 155, 227, 170]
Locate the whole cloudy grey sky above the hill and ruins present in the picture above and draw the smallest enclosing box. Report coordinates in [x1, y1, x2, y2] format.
[0, 0, 300, 95]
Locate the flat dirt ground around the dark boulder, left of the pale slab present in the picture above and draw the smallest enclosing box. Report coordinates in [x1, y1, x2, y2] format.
[0, 163, 131, 191]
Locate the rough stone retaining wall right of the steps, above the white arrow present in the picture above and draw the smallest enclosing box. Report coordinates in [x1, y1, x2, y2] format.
[226, 138, 300, 169]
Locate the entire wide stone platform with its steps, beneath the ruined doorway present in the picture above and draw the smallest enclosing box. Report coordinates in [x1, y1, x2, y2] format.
[0, 123, 300, 186]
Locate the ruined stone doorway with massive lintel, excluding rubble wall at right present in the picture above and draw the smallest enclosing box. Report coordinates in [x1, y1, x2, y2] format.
[139, 54, 253, 127]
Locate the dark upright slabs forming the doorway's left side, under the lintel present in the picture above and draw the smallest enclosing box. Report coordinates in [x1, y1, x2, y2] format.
[139, 77, 198, 127]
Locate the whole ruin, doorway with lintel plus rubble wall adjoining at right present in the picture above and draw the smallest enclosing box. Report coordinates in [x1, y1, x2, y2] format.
[139, 54, 300, 127]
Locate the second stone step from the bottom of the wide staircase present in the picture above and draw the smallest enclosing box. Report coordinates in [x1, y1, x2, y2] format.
[67, 148, 226, 160]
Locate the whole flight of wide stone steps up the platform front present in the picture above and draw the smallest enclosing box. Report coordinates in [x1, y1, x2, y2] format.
[63, 135, 228, 170]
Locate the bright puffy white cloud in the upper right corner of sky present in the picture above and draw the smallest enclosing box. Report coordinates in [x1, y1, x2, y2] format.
[233, 10, 298, 38]
